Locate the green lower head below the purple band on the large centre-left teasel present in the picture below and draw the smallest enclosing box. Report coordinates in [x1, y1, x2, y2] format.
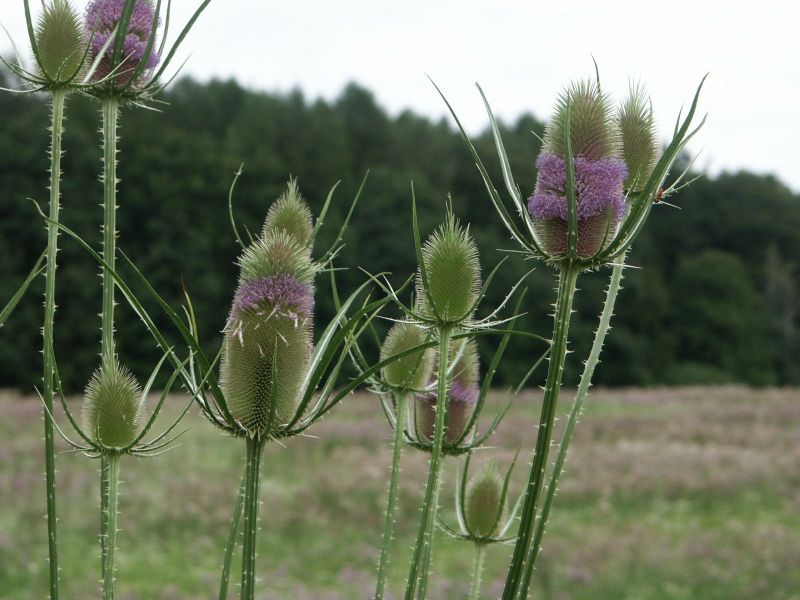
[225, 311, 312, 435]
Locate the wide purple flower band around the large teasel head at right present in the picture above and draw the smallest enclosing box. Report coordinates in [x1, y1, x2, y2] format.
[528, 152, 628, 221]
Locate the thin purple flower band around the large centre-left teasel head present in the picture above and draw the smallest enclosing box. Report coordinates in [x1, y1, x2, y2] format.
[232, 275, 314, 318]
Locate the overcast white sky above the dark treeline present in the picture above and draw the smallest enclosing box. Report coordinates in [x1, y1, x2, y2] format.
[0, 0, 800, 191]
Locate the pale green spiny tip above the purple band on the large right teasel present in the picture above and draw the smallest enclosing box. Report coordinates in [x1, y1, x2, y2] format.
[542, 80, 621, 160]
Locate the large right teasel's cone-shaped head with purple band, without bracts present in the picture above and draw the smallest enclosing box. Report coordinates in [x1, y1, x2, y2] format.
[528, 82, 628, 257]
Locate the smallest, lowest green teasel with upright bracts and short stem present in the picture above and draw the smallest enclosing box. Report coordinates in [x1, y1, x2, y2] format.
[438, 452, 522, 600]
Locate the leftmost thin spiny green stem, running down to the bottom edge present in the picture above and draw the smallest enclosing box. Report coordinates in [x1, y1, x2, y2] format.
[42, 89, 67, 600]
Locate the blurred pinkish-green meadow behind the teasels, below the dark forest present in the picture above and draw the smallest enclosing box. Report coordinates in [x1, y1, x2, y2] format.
[0, 387, 800, 600]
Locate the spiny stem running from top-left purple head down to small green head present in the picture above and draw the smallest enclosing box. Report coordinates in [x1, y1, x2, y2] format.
[100, 96, 119, 365]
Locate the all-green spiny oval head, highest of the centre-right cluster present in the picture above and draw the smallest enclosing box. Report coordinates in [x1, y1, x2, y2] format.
[417, 214, 481, 324]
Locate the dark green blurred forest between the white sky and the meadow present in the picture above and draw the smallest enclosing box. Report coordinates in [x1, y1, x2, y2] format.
[0, 74, 800, 391]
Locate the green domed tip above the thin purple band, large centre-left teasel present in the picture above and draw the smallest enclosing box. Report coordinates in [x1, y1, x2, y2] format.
[238, 230, 316, 283]
